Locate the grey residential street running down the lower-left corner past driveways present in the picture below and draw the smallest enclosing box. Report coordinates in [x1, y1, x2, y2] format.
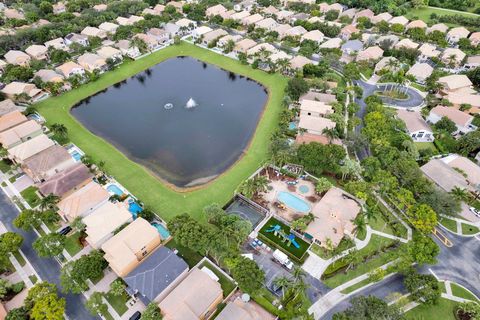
[0, 191, 97, 320]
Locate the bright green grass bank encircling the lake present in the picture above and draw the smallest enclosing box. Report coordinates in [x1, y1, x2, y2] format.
[36, 43, 287, 221]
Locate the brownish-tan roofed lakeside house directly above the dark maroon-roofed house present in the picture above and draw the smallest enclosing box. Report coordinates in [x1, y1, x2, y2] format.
[22, 145, 75, 183]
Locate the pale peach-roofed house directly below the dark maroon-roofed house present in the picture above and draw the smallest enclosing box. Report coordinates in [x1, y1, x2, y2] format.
[57, 181, 110, 222]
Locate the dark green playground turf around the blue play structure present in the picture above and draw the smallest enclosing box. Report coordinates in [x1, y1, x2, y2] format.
[259, 218, 310, 260]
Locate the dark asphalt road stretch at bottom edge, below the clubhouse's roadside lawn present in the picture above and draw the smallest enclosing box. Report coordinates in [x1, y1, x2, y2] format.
[321, 274, 406, 320]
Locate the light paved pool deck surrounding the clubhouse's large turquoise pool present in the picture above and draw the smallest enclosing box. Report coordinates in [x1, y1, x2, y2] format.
[261, 179, 320, 222]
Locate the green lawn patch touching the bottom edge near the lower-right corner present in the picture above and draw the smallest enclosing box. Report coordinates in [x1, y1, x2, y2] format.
[404, 298, 458, 320]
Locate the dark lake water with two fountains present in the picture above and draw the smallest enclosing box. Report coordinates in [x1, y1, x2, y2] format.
[71, 57, 268, 187]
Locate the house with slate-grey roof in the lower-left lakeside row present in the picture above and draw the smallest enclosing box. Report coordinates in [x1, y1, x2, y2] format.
[123, 246, 188, 304]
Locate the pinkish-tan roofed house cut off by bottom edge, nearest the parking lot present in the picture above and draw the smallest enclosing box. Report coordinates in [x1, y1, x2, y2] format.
[215, 296, 276, 320]
